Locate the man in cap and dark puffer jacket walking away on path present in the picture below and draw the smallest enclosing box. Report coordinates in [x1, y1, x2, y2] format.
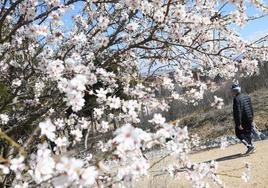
[231, 84, 255, 154]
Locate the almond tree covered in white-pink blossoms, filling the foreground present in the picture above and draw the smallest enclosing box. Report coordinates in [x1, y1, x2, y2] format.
[0, 0, 268, 187]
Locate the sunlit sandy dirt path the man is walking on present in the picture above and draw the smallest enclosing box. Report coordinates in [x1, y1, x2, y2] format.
[135, 140, 268, 188]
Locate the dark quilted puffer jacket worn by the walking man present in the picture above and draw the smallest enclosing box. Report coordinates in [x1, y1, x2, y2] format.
[233, 93, 254, 130]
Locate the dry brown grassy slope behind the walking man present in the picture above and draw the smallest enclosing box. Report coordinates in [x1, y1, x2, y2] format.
[179, 89, 268, 140]
